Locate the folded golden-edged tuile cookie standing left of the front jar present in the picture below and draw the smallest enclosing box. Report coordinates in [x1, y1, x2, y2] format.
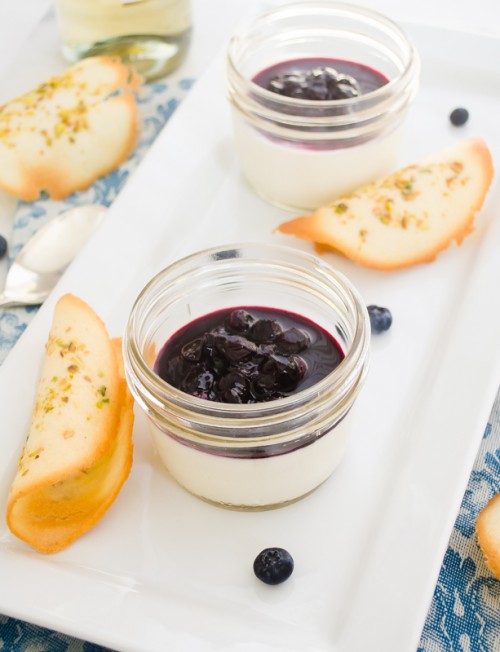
[7, 295, 134, 553]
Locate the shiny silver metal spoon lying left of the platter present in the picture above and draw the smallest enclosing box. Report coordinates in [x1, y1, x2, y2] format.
[0, 205, 106, 308]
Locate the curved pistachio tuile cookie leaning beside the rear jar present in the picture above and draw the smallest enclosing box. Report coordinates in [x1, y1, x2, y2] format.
[277, 139, 493, 270]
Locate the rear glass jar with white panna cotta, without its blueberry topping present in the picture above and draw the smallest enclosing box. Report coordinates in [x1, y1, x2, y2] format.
[226, 0, 420, 211]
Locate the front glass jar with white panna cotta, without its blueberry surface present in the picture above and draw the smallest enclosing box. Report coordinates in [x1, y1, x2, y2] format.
[124, 244, 371, 510]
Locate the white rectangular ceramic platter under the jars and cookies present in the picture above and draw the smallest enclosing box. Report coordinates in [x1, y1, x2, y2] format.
[0, 26, 500, 652]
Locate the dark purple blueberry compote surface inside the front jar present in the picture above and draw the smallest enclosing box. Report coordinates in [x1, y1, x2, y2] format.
[154, 307, 344, 404]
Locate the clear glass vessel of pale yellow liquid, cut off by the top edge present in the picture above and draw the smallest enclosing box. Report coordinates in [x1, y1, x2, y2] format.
[55, 0, 191, 80]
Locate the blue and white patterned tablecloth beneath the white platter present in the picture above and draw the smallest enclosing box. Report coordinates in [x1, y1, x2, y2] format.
[0, 57, 500, 652]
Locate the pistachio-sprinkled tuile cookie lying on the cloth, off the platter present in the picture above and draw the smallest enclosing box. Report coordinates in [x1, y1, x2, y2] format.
[0, 57, 139, 201]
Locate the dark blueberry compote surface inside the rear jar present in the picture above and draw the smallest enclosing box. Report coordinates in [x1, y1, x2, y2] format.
[252, 58, 389, 101]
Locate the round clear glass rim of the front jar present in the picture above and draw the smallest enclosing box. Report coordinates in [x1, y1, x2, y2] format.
[124, 243, 370, 424]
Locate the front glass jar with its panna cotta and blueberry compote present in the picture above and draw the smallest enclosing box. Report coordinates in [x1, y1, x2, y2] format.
[124, 244, 370, 510]
